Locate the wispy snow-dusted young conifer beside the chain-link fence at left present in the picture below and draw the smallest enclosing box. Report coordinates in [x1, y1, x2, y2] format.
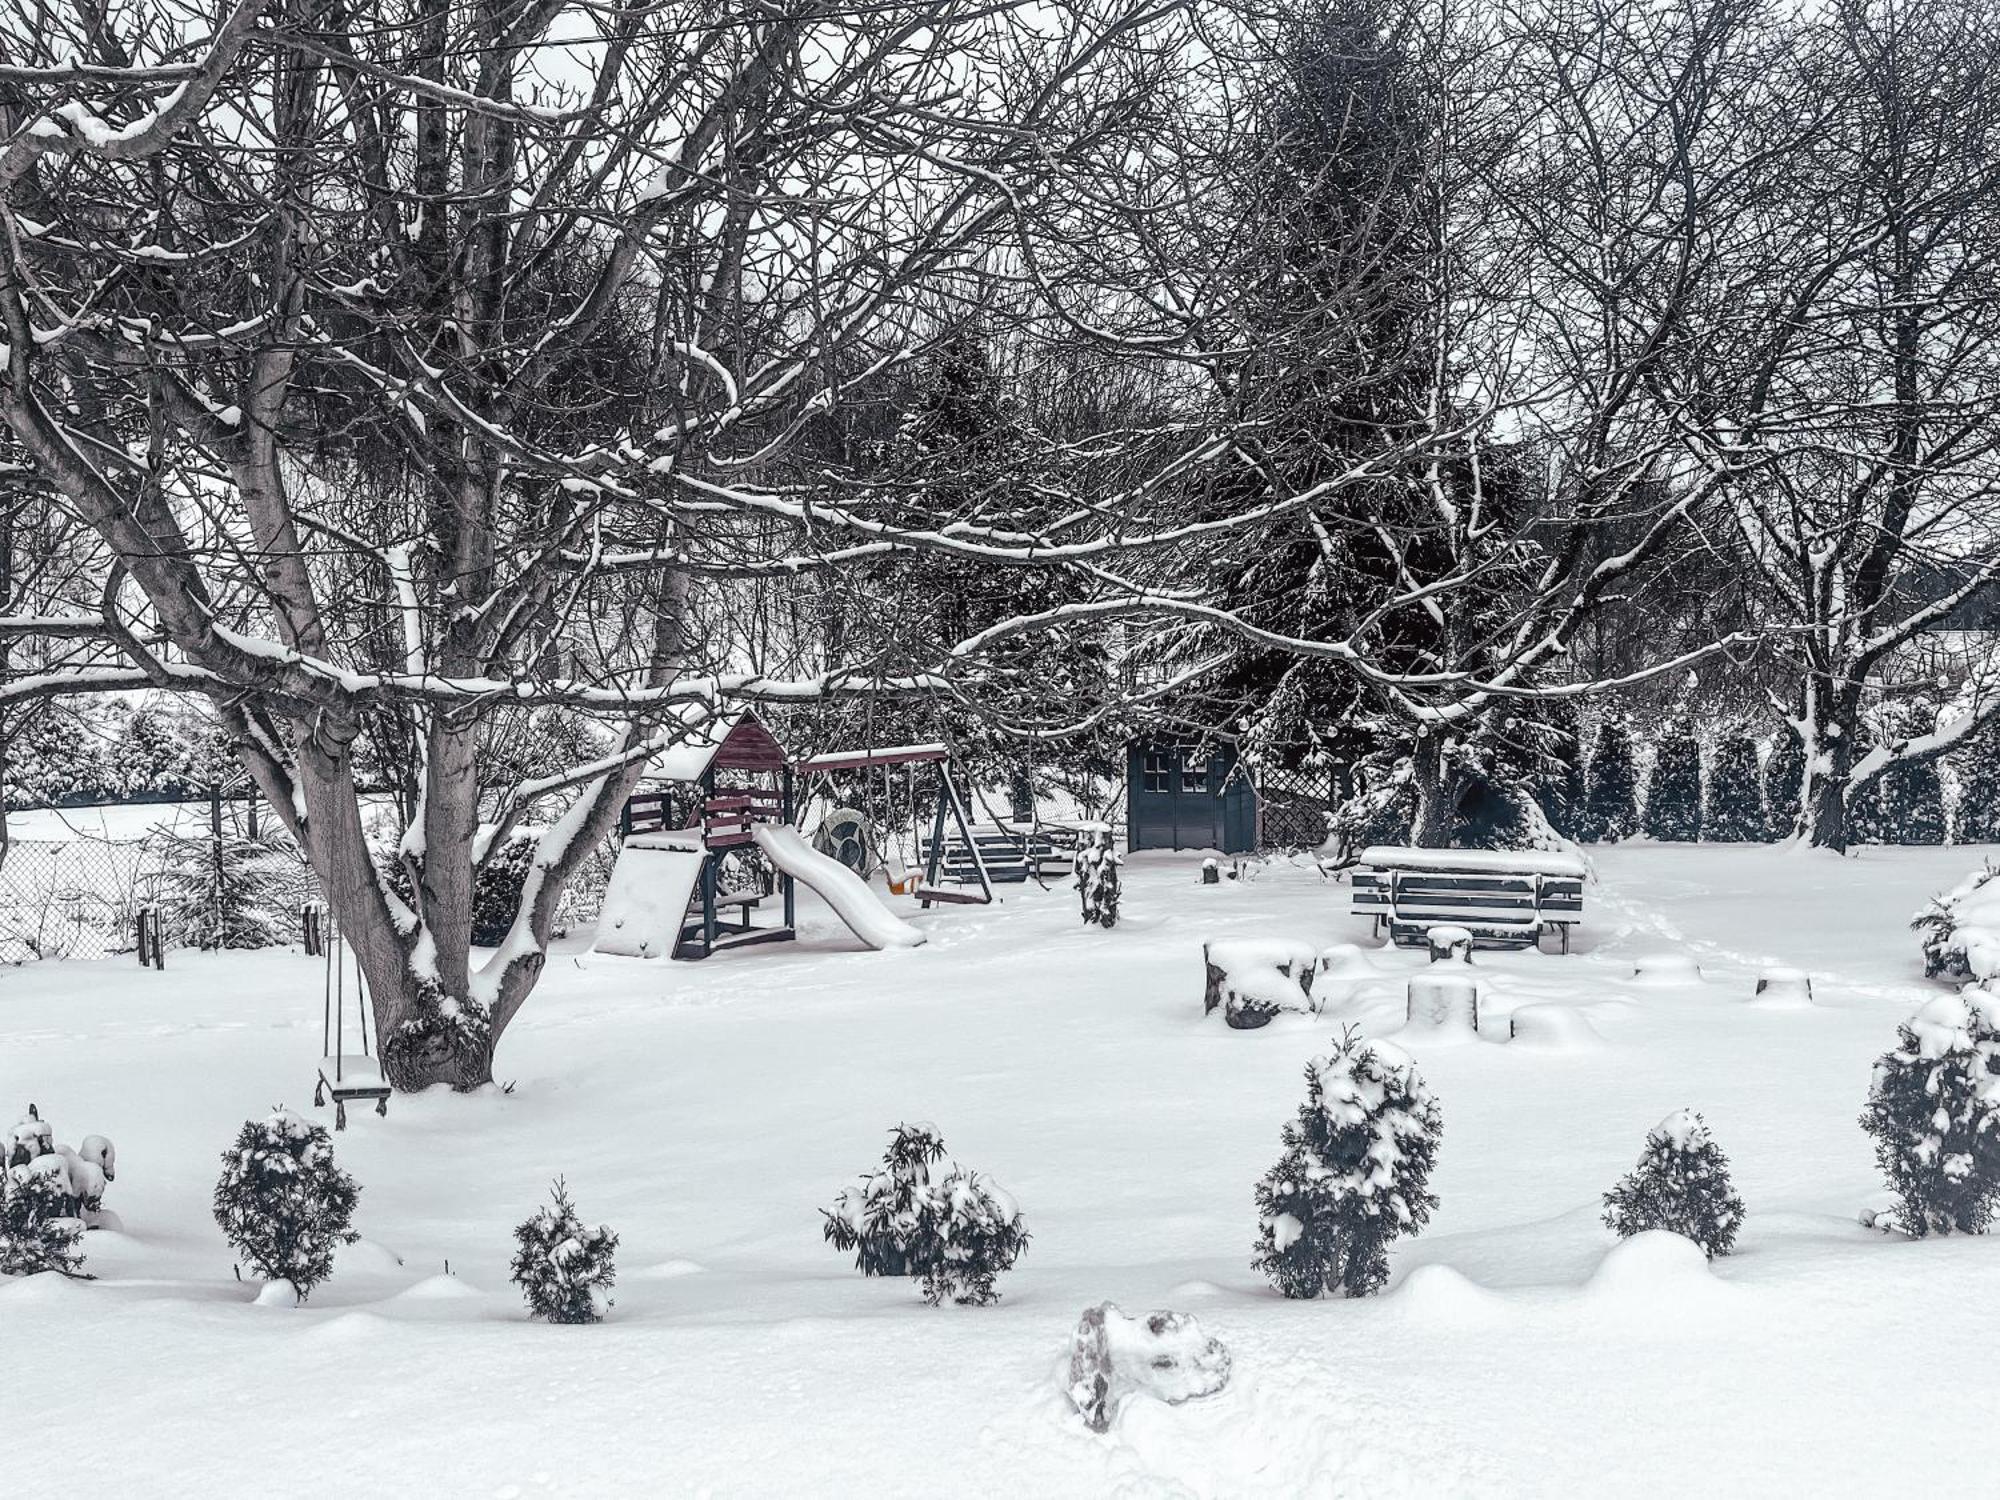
[154, 832, 304, 948]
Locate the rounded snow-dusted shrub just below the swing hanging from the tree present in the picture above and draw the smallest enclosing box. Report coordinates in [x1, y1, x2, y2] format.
[214, 1110, 360, 1302]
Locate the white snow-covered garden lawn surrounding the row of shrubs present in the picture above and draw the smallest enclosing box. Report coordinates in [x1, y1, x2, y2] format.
[0, 846, 2000, 1500]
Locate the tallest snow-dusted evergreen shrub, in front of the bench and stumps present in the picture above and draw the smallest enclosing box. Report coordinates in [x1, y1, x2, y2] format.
[1252, 1026, 1444, 1298]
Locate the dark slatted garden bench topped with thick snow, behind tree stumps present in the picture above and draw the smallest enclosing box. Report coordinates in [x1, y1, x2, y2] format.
[1348, 846, 1588, 952]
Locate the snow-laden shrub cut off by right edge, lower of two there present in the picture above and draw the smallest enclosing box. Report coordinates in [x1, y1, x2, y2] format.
[1862, 990, 2000, 1238]
